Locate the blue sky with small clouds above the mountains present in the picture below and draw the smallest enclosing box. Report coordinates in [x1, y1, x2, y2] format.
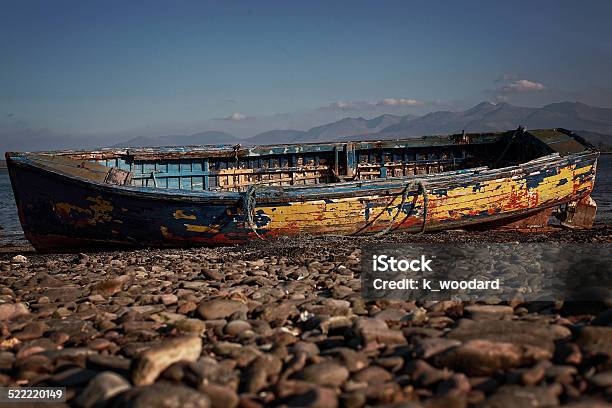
[0, 0, 612, 139]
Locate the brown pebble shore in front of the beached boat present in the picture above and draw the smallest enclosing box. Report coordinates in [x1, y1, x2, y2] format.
[0, 225, 612, 408]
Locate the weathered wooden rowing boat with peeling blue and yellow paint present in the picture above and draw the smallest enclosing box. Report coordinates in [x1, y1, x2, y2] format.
[6, 128, 598, 251]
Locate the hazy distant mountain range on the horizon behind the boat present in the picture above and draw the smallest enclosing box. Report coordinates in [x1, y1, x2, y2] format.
[114, 102, 612, 147]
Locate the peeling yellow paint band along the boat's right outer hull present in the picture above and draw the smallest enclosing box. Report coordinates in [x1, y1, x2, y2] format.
[251, 161, 593, 233]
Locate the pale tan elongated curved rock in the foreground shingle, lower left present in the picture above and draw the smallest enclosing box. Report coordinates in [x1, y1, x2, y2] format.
[132, 336, 202, 385]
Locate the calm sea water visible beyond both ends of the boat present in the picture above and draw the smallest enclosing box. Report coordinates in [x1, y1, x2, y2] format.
[0, 154, 612, 245]
